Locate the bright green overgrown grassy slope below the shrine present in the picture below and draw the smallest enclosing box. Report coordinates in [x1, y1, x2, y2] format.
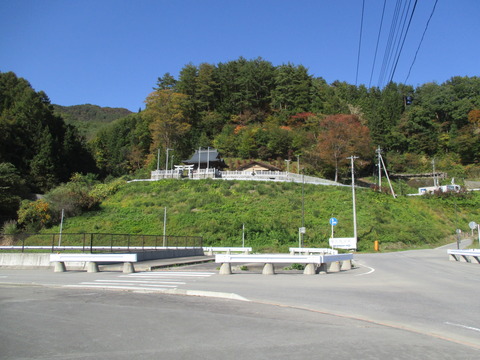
[53, 180, 480, 251]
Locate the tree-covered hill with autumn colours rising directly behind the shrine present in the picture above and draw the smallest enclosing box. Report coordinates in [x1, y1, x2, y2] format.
[93, 58, 480, 180]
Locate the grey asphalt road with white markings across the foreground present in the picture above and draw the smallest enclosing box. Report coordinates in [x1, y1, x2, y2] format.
[0, 243, 480, 359]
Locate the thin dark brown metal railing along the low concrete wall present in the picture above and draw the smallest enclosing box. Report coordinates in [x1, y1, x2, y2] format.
[0, 233, 203, 253]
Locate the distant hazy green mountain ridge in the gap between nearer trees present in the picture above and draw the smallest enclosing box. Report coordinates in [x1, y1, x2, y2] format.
[53, 104, 132, 140]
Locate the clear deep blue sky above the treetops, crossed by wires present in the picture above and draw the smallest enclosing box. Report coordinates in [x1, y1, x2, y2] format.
[0, 0, 480, 111]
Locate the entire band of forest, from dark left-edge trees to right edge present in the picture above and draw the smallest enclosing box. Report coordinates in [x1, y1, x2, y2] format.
[0, 58, 480, 224]
